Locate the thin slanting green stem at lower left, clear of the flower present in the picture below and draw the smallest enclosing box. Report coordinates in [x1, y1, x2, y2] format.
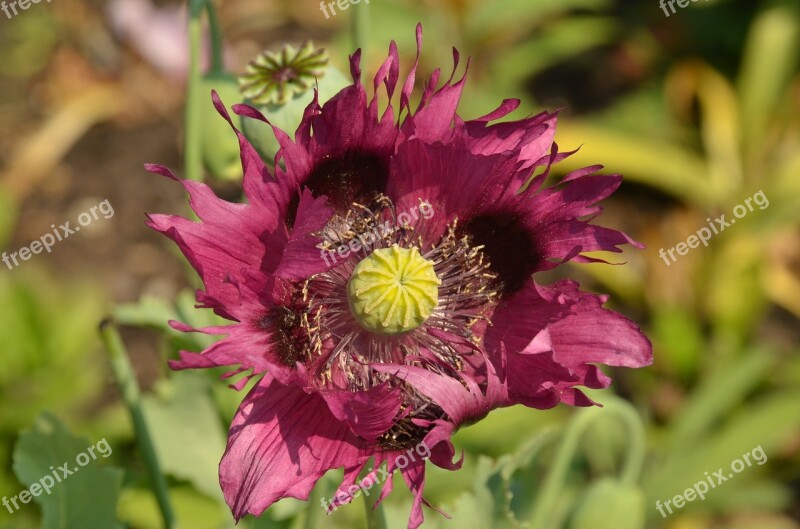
[100, 320, 177, 529]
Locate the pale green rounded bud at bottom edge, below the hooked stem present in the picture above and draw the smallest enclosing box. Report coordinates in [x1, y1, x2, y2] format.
[569, 478, 645, 529]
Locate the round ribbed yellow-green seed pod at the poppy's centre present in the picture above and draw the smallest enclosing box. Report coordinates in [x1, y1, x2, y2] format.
[347, 244, 442, 335]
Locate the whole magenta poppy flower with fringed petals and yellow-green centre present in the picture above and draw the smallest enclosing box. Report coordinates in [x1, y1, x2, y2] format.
[148, 22, 652, 528]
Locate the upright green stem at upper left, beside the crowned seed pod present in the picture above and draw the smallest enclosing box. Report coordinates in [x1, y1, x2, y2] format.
[183, 9, 203, 181]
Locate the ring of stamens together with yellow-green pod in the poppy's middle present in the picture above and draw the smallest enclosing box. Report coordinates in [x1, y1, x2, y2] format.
[305, 196, 500, 449]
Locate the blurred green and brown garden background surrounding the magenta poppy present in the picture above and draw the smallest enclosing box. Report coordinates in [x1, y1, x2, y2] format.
[0, 0, 800, 529]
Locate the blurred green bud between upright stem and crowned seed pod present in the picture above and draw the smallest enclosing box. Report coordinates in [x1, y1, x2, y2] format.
[199, 73, 242, 180]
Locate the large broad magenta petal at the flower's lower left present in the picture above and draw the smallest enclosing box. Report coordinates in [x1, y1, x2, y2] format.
[219, 375, 368, 520]
